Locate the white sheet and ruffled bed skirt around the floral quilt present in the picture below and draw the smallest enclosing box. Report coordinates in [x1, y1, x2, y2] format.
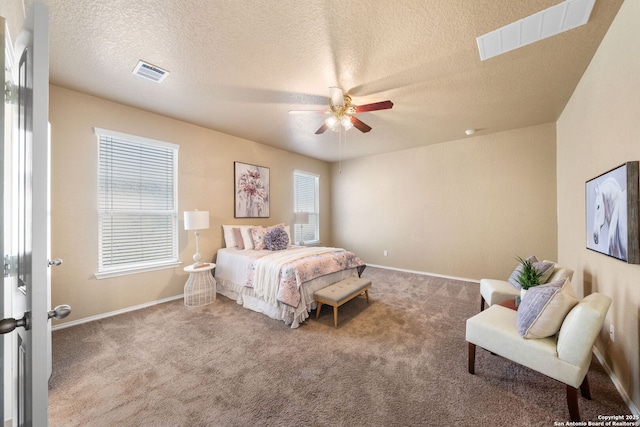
[215, 248, 358, 328]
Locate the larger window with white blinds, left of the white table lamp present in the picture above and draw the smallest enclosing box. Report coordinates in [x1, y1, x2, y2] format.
[95, 128, 179, 279]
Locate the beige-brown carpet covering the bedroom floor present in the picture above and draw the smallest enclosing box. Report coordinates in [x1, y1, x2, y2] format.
[49, 267, 629, 427]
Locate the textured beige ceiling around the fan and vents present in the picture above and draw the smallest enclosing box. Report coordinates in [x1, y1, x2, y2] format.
[18, 0, 623, 161]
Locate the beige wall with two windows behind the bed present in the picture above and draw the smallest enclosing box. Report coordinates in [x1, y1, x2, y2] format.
[50, 86, 331, 324]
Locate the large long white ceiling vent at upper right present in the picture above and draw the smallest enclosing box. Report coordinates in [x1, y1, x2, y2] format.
[476, 0, 596, 61]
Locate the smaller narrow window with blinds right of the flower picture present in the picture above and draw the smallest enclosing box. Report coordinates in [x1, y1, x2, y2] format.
[293, 171, 320, 244]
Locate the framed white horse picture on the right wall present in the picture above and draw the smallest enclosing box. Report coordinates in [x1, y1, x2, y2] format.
[585, 161, 640, 264]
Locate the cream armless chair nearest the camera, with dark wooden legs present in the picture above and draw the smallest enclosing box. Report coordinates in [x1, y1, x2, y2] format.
[466, 293, 611, 421]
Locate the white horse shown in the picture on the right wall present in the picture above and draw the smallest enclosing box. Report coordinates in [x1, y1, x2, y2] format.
[593, 178, 627, 260]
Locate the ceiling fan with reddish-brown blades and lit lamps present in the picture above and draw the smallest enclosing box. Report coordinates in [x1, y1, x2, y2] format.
[289, 87, 393, 135]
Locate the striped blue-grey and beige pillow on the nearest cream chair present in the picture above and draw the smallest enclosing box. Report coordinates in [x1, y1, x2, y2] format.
[517, 278, 578, 338]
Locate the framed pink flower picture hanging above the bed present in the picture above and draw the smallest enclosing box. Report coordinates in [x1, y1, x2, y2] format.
[233, 162, 270, 218]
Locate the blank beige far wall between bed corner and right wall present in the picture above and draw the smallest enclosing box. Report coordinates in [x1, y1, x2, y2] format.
[332, 124, 557, 279]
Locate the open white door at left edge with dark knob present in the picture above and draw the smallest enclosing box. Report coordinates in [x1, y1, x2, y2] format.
[2, 3, 68, 426]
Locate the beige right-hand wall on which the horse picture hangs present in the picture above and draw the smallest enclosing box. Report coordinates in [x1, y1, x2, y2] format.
[558, 0, 640, 414]
